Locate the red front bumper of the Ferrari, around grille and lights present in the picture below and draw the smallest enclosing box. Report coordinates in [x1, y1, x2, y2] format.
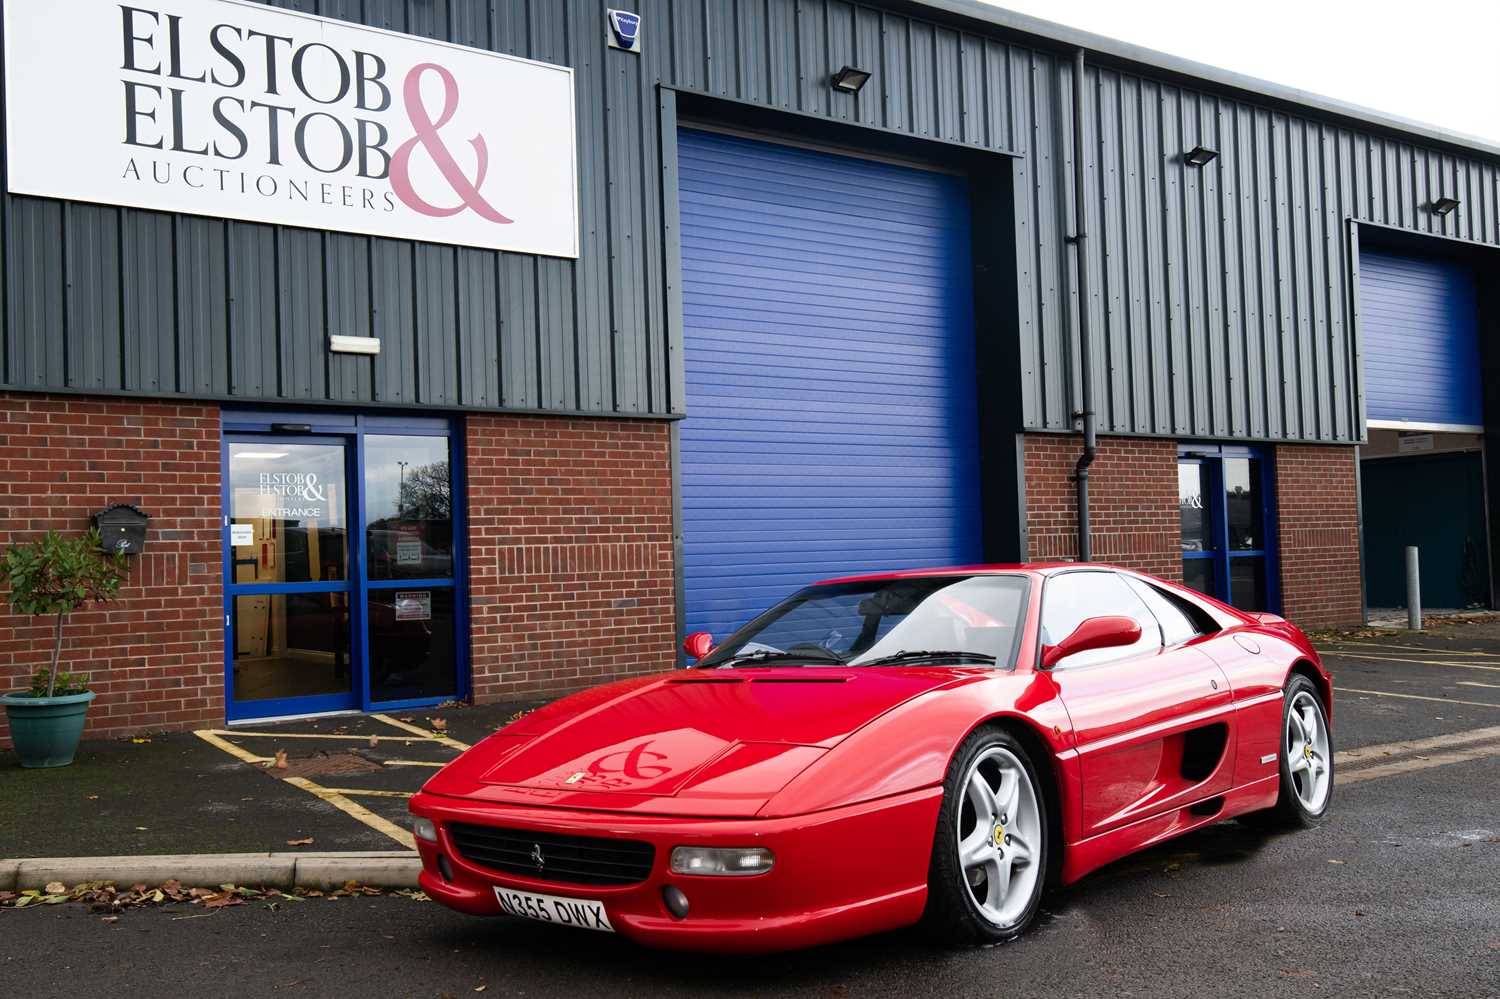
[411, 788, 942, 953]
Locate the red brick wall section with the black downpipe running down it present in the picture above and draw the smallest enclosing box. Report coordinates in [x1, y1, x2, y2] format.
[1025, 434, 1182, 581]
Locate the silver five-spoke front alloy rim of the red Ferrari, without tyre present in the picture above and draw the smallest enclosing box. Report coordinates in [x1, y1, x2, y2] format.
[959, 746, 1041, 927]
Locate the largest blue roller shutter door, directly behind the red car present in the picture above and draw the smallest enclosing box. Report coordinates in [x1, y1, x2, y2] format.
[678, 131, 981, 638]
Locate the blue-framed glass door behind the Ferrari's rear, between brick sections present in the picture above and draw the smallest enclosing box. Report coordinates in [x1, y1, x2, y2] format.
[1178, 446, 1280, 611]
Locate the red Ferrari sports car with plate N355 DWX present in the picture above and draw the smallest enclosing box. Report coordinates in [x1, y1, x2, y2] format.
[411, 563, 1334, 951]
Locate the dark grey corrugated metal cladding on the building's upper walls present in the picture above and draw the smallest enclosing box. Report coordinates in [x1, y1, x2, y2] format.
[5, 0, 1500, 441]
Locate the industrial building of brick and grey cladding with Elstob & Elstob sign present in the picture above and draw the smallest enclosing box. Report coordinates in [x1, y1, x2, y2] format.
[0, 0, 1500, 738]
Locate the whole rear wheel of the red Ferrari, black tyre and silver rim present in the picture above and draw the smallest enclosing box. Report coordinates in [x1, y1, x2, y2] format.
[1242, 674, 1334, 830]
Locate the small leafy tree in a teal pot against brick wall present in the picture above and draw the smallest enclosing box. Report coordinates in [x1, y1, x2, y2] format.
[0, 531, 126, 767]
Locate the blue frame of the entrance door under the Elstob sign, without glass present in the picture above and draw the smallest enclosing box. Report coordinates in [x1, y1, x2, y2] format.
[219, 410, 470, 722]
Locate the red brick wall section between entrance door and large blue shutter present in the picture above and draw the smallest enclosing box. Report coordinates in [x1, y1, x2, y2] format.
[465, 416, 677, 701]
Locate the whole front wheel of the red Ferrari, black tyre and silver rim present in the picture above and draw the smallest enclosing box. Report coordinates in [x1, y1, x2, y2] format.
[923, 728, 1049, 945]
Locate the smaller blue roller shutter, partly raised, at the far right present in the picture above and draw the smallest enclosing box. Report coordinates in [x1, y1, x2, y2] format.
[1359, 251, 1485, 428]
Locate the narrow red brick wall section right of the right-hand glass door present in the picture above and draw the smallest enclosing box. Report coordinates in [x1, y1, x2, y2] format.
[1275, 444, 1364, 627]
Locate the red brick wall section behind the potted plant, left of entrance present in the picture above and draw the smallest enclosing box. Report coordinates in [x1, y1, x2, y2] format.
[0, 393, 224, 744]
